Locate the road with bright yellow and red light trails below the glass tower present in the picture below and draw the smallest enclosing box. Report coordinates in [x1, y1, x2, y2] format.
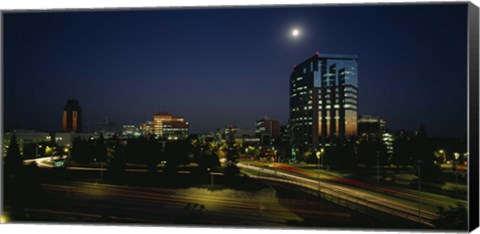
[238, 163, 464, 226]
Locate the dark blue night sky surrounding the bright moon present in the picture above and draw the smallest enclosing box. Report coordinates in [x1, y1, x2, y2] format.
[3, 4, 467, 137]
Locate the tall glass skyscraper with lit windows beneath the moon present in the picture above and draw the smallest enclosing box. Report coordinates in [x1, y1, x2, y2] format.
[289, 53, 358, 148]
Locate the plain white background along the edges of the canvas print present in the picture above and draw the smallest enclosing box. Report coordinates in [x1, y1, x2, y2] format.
[0, 0, 480, 234]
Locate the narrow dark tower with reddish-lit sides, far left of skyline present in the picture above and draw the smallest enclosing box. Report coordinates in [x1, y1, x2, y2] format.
[62, 100, 82, 132]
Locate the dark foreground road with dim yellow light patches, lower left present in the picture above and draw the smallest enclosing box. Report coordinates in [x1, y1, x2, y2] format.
[7, 182, 368, 226]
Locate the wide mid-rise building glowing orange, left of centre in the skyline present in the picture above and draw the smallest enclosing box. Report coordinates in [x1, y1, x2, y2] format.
[153, 113, 189, 140]
